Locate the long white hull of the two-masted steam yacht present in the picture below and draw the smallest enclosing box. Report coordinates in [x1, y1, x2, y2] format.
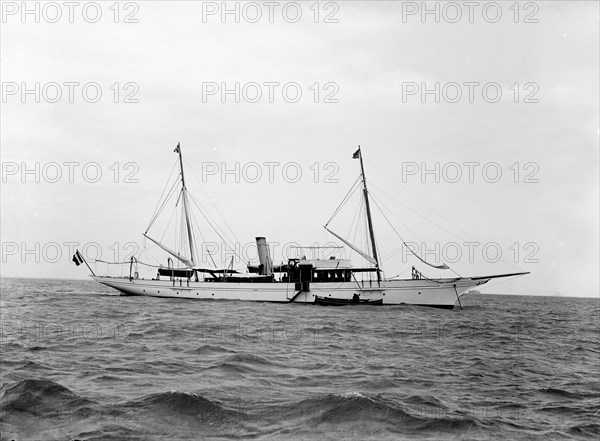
[92, 276, 489, 308]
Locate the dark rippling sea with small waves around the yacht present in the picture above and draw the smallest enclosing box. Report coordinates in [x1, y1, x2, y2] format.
[0, 279, 600, 440]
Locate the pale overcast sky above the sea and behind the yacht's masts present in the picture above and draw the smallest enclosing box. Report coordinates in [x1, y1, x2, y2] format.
[0, 1, 600, 297]
